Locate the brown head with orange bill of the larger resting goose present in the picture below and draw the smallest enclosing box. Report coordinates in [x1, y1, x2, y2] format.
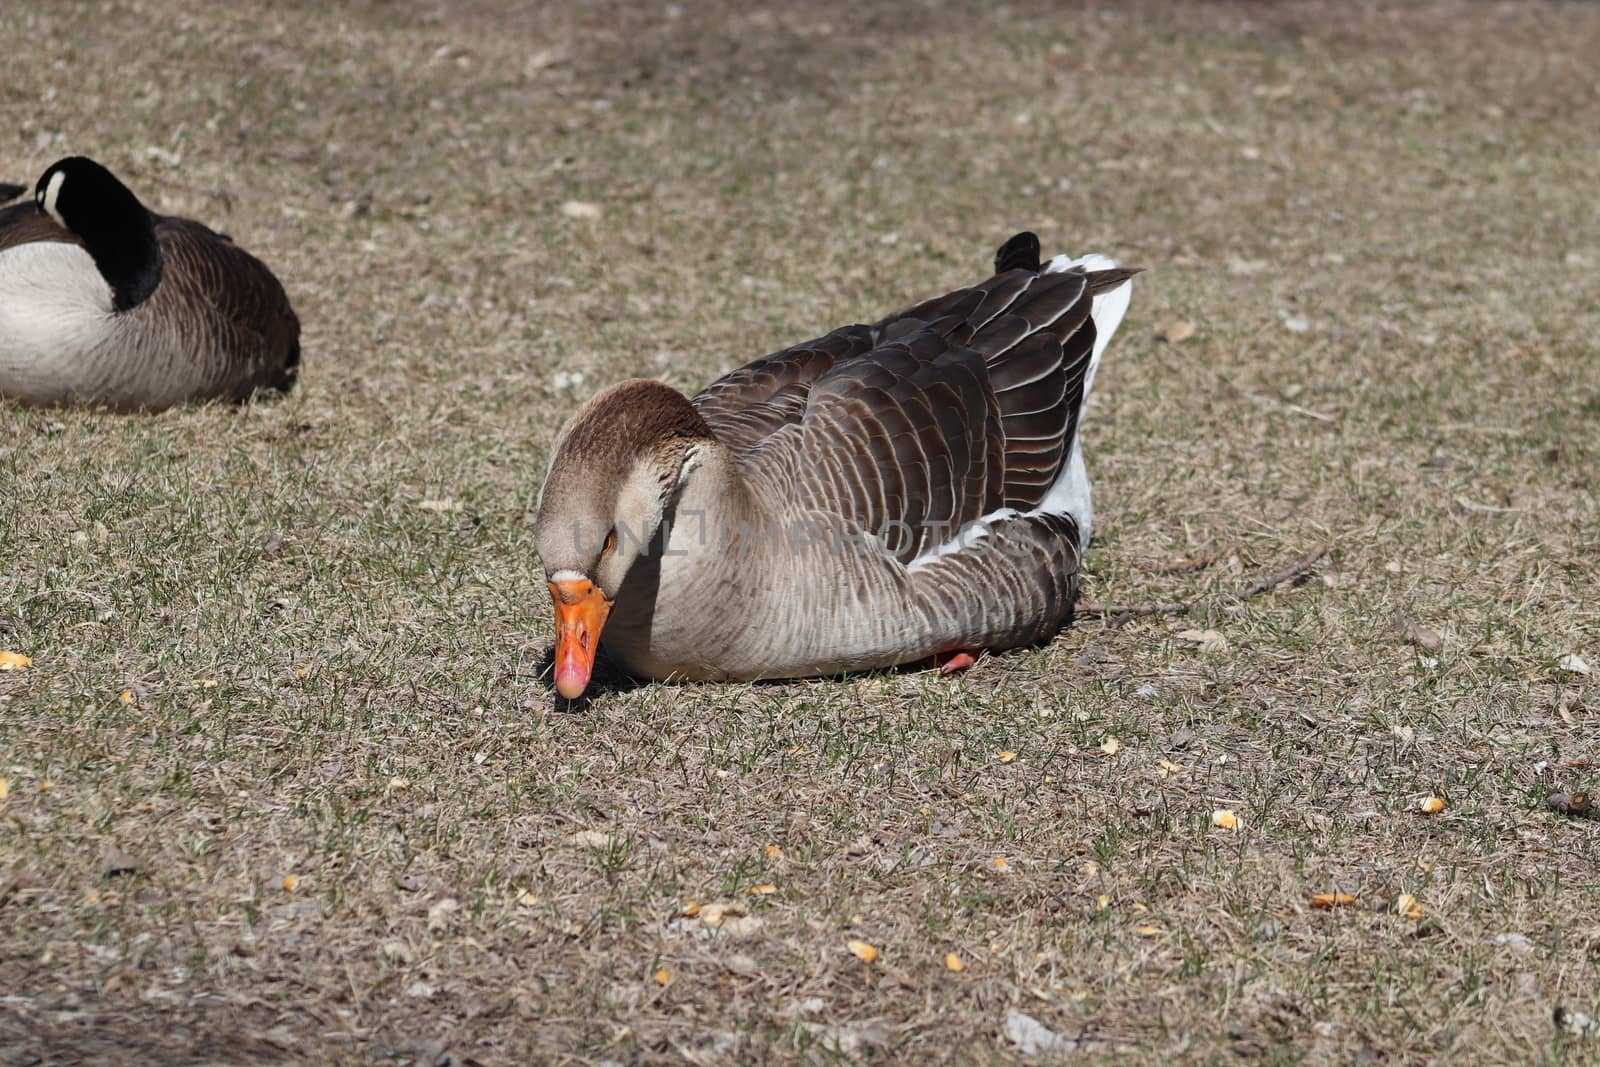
[534, 379, 714, 701]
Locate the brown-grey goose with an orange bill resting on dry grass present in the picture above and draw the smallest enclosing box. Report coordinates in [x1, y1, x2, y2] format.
[534, 234, 1138, 699]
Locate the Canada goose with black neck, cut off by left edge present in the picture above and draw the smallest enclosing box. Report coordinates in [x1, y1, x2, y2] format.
[0, 155, 299, 411]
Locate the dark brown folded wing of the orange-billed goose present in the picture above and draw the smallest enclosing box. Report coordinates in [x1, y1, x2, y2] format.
[694, 235, 1133, 563]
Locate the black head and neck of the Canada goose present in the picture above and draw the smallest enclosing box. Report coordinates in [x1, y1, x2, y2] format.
[34, 155, 162, 312]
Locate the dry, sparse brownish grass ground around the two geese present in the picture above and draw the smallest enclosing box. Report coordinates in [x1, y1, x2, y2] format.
[0, 0, 1600, 1065]
